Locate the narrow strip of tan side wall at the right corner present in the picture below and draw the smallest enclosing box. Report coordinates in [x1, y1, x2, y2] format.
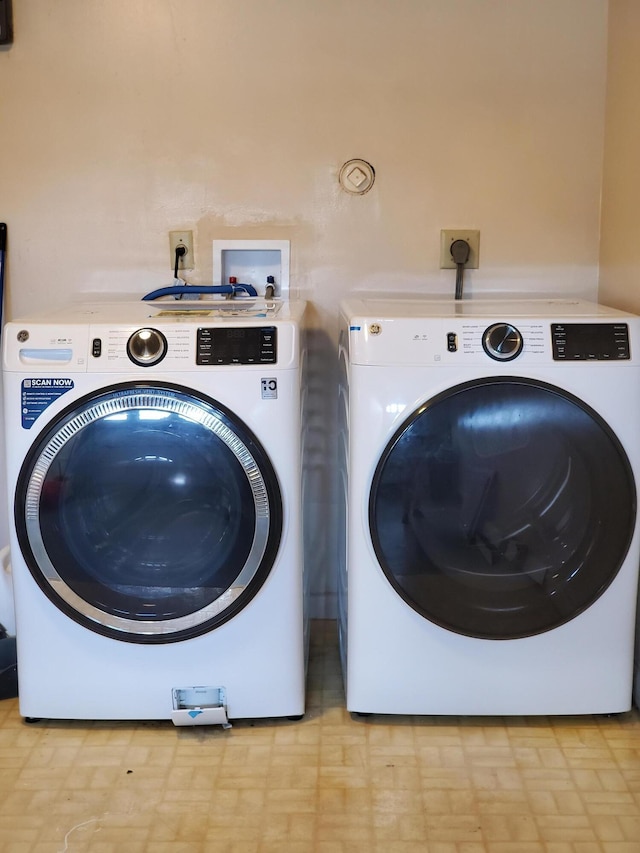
[599, 0, 640, 313]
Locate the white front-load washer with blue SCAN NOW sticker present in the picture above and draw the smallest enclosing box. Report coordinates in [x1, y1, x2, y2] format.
[3, 301, 307, 724]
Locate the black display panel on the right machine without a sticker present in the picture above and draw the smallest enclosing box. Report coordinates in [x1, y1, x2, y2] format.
[551, 323, 631, 361]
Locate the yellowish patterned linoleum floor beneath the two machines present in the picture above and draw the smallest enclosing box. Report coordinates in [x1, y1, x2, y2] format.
[0, 621, 640, 853]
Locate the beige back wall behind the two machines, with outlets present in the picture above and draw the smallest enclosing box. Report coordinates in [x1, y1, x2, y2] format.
[0, 0, 608, 609]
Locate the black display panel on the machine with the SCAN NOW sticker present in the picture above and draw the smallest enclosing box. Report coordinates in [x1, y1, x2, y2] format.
[196, 326, 278, 365]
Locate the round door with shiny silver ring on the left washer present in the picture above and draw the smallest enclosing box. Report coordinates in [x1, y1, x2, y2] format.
[15, 383, 282, 643]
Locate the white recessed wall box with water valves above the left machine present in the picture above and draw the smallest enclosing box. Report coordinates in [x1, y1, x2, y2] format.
[213, 240, 291, 298]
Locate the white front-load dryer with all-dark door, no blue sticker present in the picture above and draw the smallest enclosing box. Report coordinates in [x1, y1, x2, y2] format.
[339, 299, 640, 715]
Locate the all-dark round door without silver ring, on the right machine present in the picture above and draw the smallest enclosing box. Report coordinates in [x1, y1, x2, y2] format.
[369, 377, 636, 639]
